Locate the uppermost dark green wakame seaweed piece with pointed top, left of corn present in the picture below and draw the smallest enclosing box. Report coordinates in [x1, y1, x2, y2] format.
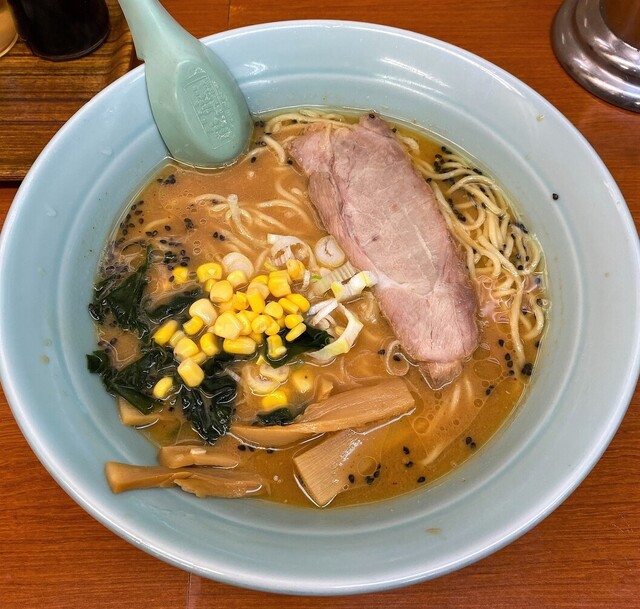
[90, 249, 150, 337]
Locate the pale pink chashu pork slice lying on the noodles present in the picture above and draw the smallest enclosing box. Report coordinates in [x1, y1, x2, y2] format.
[288, 114, 478, 388]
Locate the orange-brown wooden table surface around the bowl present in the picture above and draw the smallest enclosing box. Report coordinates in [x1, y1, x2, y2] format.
[0, 0, 640, 609]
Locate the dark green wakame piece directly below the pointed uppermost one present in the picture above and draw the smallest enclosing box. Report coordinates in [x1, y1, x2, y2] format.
[87, 347, 176, 414]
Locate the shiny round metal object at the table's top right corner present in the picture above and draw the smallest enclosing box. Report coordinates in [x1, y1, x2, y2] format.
[552, 0, 640, 112]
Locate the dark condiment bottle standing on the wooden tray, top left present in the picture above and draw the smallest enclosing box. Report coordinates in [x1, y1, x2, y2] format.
[9, 0, 109, 61]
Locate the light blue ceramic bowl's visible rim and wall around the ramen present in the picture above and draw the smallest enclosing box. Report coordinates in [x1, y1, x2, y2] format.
[0, 22, 640, 595]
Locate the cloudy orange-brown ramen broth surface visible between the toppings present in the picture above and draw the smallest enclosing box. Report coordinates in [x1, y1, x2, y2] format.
[92, 108, 548, 506]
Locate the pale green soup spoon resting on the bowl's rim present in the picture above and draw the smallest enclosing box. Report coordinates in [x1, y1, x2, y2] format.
[119, 0, 253, 167]
